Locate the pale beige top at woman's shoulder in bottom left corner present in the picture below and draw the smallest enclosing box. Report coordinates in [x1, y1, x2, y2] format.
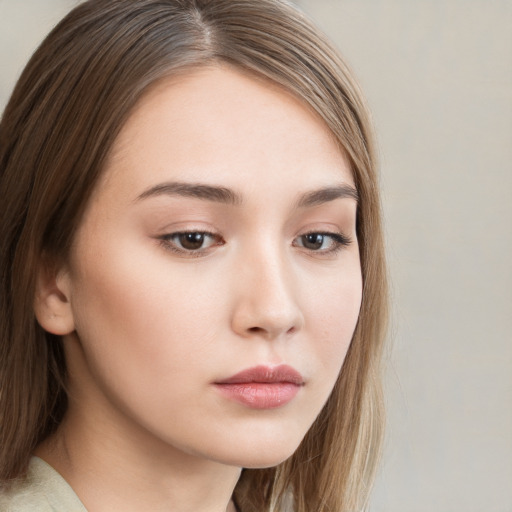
[0, 457, 87, 512]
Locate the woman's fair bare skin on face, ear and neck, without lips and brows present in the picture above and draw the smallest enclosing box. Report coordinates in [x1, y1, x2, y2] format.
[36, 65, 362, 512]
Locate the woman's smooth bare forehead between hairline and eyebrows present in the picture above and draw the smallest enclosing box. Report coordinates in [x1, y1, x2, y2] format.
[102, 65, 353, 197]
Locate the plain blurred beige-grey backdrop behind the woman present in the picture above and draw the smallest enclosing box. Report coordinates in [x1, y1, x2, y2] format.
[0, 0, 512, 512]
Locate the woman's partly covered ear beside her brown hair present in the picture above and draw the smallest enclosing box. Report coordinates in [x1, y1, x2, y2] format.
[34, 263, 75, 336]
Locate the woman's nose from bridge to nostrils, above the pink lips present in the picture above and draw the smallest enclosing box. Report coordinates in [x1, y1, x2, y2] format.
[232, 247, 304, 340]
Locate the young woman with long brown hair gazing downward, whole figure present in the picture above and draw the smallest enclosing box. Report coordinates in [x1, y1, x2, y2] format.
[0, 0, 386, 512]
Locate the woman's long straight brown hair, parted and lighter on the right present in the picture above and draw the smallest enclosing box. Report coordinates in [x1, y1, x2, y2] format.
[0, 0, 386, 512]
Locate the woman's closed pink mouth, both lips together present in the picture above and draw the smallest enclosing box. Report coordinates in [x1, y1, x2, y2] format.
[215, 365, 305, 409]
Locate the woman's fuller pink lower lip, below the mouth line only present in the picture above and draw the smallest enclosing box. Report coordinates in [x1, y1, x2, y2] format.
[216, 382, 300, 409]
